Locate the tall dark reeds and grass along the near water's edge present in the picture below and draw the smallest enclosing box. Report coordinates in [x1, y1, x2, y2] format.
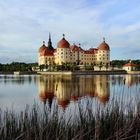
[0, 100, 140, 140]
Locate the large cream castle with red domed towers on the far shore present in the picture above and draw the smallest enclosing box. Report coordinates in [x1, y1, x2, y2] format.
[38, 34, 110, 66]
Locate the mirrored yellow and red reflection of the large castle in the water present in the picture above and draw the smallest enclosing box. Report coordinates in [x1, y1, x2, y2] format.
[38, 75, 110, 109]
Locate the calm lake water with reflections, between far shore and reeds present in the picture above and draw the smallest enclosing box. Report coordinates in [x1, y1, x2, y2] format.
[0, 75, 140, 111]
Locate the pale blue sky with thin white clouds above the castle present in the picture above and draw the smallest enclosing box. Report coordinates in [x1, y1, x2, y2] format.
[0, 0, 140, 63]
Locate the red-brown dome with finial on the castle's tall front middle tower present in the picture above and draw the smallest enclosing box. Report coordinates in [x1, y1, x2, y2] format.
[57, 34, 70, 48]
